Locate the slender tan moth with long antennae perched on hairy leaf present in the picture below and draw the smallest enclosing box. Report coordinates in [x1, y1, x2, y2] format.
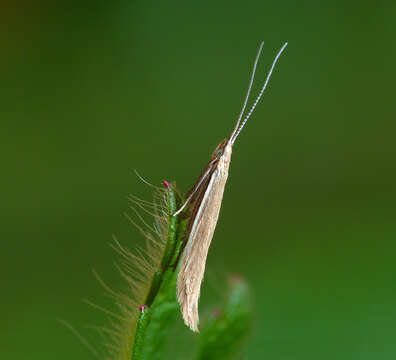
[173, 42, 287, 332]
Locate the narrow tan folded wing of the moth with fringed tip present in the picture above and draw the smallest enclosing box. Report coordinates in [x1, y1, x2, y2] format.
[177, 146, 232, 331]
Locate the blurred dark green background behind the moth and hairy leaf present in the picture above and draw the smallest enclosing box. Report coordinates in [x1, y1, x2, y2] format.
[0, 0, 396, 360]
